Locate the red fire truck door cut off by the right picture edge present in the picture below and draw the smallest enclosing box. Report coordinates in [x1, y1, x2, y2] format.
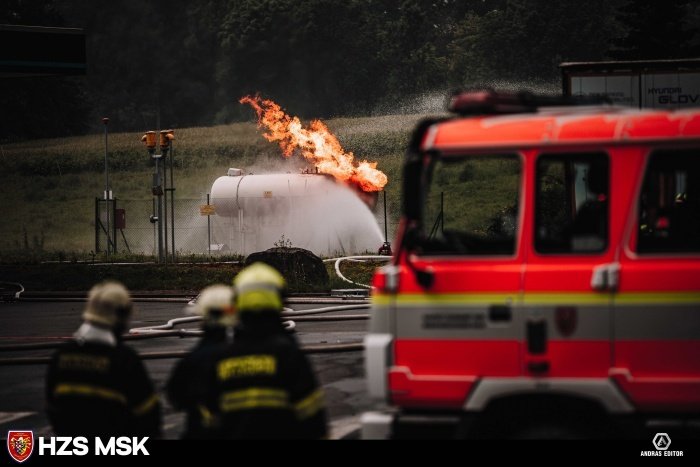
[613, 149, 700, 411]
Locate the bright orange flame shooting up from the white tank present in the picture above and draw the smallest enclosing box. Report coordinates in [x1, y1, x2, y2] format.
[239, 96, 388, 191]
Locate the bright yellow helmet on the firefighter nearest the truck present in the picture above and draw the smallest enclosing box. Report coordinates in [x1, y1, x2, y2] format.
[233, 263, 285, 313]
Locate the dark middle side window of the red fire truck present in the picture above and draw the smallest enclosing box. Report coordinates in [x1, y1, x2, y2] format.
[535, 153, 610, 254]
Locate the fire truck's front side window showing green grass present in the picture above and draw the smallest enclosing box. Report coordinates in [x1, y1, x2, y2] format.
[421, 155, 521, 256]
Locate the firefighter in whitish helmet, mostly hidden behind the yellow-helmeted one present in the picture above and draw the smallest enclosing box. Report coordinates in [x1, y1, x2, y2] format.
[166, 285, 235, 439]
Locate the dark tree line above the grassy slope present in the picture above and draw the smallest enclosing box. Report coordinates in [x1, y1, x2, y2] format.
[0, 0, 700, 141]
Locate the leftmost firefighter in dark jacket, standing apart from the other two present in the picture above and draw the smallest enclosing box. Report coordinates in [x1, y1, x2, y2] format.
[46, 282, 161, 437]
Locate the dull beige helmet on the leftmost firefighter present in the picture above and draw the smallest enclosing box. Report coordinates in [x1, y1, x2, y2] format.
[83, 281, 132, 328]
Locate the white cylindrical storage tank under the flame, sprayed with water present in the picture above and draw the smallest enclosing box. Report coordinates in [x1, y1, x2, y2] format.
[211, 168, 384, 256]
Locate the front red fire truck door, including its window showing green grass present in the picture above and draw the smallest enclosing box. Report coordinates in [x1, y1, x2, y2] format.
[390, 155, 524, 408]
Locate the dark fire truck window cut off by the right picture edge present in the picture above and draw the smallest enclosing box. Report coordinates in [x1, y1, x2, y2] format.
[637, 149, 700, 253]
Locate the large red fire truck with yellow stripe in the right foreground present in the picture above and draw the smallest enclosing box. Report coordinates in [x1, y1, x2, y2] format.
[362, 91, 700, 438]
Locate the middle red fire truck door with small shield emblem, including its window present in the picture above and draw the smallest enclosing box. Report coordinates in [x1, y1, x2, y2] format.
[523, 153, 615, 377]
